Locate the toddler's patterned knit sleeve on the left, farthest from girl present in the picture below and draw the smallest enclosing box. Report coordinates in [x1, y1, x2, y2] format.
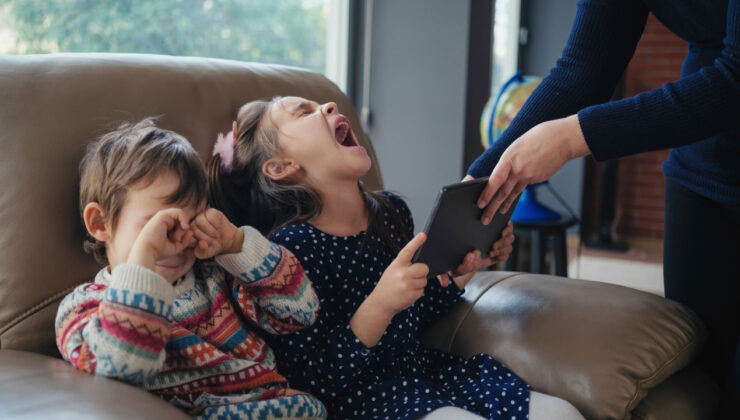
[55, 264, 175, 384]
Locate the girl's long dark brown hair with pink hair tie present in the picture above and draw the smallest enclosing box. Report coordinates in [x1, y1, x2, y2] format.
[206, 97, 410, 253]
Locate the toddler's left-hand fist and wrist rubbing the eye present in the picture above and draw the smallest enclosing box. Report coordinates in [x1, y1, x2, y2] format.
[128, 208, 193, 270]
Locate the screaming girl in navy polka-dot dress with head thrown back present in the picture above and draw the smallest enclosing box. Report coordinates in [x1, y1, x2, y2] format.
[208, 97, 582, 419]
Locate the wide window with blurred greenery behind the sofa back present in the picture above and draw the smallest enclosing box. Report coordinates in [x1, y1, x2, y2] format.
[0, 0, 349, 90]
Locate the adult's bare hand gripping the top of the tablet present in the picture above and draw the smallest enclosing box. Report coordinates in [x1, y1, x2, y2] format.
[478, 114, 591, 225]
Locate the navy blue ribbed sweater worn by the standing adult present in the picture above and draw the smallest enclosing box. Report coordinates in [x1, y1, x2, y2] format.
[468, 0, 740, 207]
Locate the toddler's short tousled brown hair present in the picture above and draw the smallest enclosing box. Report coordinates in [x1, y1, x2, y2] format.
[80, 118, 207, 264]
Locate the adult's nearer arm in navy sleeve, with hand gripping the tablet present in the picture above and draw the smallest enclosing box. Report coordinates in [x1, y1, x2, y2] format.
[472, 0, 740, 218]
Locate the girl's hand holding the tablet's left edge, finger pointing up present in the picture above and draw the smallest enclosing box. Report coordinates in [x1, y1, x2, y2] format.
[368, 233, 429, 317]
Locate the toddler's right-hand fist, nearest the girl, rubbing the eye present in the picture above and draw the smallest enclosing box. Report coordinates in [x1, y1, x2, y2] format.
[190, 209, 244, 260]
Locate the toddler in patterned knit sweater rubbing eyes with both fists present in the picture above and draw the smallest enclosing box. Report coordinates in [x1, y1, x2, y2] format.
[56, 119, 326, 419]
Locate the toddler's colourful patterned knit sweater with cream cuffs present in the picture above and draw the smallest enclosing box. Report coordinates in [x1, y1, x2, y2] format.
[55, 227, 326, 419]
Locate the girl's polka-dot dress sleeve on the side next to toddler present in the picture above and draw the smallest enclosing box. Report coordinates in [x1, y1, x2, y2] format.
[269, 228, 373, 398]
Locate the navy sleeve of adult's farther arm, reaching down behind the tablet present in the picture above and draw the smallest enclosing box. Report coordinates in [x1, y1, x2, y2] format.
[468, 0, 648, 178]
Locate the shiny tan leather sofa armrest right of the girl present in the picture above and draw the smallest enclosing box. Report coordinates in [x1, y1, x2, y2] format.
[422, 272, 705, 419]
